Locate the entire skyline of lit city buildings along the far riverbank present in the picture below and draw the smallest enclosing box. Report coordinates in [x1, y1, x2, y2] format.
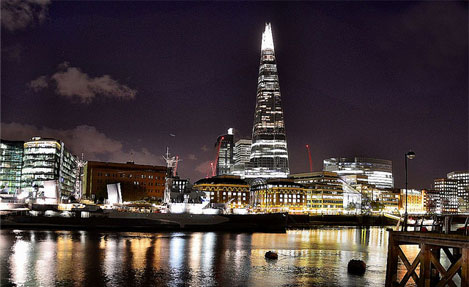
[0, 24, 469, 214]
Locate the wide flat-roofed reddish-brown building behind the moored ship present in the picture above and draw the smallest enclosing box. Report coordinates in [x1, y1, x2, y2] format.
[83, 161, 167, 201]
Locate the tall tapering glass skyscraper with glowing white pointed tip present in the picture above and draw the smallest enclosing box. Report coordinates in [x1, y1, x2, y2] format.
[246, 23, 289, 178]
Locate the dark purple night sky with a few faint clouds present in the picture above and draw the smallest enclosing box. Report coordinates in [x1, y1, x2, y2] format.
[1, 0, 469, 188]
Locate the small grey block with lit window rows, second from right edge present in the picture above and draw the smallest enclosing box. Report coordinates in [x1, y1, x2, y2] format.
[434, 178, 458, 213]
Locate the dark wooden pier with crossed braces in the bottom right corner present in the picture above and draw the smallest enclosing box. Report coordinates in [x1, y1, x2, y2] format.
[385, 231, 469, 287]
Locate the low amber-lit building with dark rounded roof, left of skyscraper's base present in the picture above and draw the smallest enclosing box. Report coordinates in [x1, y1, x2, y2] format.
[193, 175, 250, 208]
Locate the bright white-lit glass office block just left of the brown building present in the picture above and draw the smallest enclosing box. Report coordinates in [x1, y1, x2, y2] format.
[21, 137, 78, 199]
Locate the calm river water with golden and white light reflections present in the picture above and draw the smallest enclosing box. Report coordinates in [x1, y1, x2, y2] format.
[0, 227, 417, 287]
